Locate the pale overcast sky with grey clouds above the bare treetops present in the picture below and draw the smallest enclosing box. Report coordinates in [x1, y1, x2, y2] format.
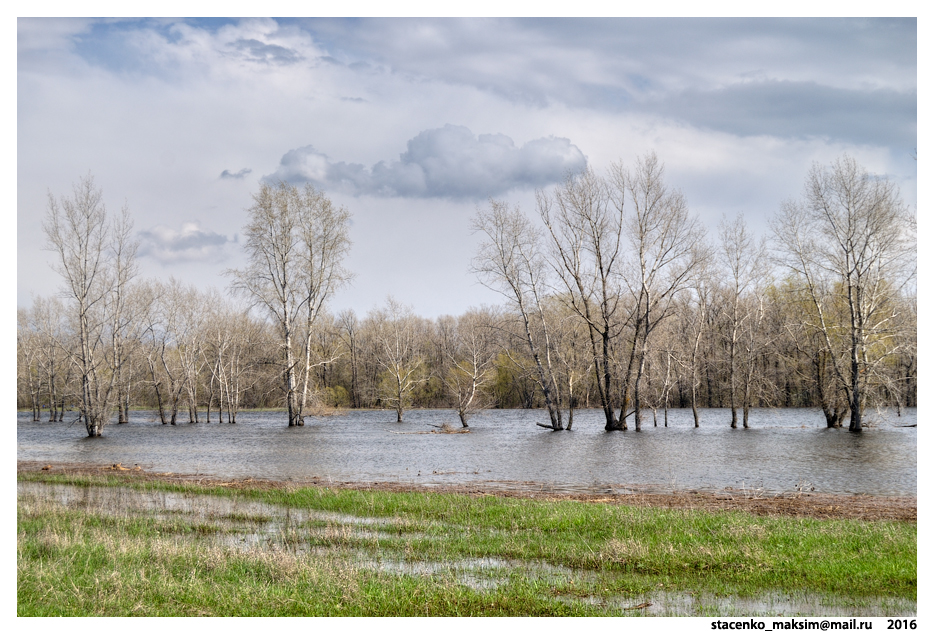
[17, 18, 917, 317]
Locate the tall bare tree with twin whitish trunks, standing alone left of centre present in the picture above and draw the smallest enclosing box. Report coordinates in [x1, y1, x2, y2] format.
[228, 182, 351, 427]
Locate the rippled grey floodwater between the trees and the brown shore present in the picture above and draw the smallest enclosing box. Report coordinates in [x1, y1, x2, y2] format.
[17, 408, 917, 496]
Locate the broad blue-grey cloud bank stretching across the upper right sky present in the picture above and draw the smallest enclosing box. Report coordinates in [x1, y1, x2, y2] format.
[304, 18, 918, 147]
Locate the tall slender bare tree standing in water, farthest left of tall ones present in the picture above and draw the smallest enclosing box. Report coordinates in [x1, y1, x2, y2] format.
[43, 174, 136, 437]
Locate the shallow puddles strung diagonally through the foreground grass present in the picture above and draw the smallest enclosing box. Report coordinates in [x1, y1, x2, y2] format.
[17, 481, 916, 617]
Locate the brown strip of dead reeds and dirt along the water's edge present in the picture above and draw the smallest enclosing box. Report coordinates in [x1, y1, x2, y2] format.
[17, 461, 917, 523]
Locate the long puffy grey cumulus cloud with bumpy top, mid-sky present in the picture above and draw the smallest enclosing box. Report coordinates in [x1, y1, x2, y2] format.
[263, 124, 587, 198]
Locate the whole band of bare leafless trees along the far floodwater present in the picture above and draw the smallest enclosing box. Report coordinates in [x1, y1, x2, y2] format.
[17, 154, 917, 436]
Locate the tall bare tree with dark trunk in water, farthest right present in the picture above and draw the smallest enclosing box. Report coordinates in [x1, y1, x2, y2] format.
[773, 156, 915, 432]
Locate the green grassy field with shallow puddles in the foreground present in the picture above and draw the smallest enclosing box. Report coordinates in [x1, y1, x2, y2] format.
[17, 473, 916, 615]
